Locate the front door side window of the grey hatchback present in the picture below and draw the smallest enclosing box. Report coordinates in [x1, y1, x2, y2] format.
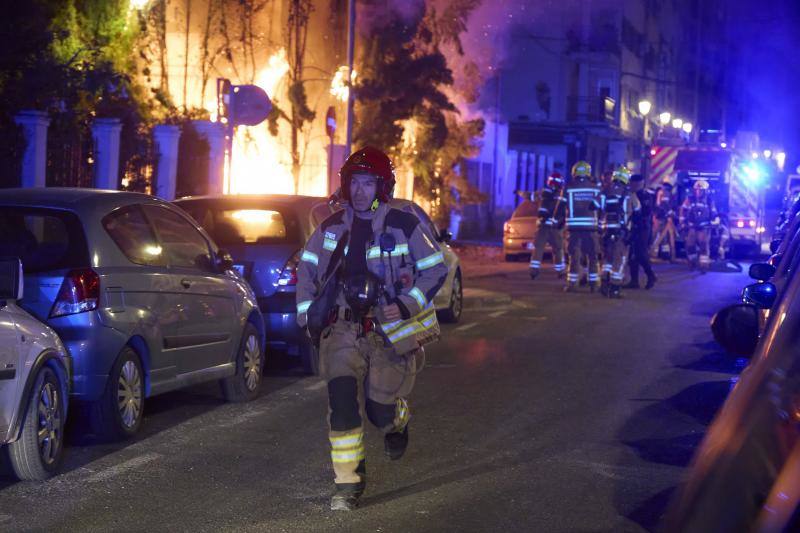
[144, 205, 214, 272]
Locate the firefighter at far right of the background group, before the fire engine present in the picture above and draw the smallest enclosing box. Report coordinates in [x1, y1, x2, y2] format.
[680, 180, 717, 274]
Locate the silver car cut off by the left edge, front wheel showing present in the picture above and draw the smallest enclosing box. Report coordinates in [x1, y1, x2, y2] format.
[0, 259, 72, 481]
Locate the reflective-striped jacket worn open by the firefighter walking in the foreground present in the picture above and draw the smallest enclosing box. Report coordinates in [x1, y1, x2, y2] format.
[296, 204, 447, 354]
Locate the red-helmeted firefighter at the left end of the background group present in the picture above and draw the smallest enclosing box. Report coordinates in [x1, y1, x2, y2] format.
[530, 172, 566, 279]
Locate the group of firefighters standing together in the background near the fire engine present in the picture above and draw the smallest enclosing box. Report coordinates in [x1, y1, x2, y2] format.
[530, 161, 719, 298]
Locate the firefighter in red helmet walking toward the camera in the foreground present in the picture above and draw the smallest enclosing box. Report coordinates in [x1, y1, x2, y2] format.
[297, 147, 447, 510]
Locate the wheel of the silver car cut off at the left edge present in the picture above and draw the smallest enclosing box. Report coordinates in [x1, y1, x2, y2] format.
[8, 366, 66, 481]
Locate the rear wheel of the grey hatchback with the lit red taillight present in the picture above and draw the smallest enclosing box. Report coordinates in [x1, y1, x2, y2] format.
[91, 346, 144, 440]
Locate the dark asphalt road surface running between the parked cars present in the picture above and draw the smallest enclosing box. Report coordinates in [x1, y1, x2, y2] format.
[0, 263, 747, 532]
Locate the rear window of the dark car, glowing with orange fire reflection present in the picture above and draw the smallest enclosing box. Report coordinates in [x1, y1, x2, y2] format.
[178, 202, 300, 247]
